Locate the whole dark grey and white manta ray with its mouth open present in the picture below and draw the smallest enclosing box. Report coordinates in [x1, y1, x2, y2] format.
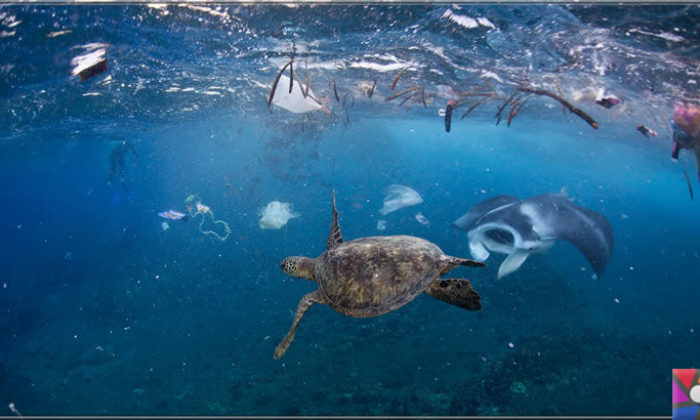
[454, 193, 614, 278]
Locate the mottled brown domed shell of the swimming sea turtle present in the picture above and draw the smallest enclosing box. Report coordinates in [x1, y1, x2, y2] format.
[314, 236, 445, 318]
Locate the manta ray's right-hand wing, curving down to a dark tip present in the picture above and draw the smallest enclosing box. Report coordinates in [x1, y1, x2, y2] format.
[523, 194, 614, 275]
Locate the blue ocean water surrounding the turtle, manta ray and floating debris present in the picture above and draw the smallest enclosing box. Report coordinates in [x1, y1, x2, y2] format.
[0, 4, 700, 415]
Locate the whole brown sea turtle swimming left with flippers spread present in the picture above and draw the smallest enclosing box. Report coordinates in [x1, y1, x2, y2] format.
[274, 192, 484, 359]
